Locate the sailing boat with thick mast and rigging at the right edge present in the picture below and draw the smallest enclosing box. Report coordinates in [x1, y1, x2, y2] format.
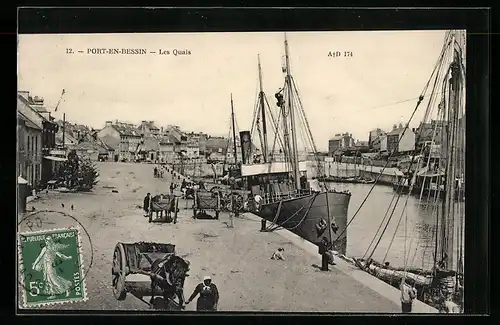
[353, 31, 465, 312]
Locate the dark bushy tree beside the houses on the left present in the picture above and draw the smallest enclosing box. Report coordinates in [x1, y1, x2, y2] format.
[58, 150, 99, 192]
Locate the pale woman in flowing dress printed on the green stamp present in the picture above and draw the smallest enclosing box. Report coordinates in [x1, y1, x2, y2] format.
[32, 236, 72, 298]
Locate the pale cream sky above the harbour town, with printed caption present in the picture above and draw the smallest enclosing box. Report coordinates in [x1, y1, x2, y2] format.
[18, 31, 445, 150]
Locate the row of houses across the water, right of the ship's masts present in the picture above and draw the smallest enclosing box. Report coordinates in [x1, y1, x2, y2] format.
[328, 120, 452, 156]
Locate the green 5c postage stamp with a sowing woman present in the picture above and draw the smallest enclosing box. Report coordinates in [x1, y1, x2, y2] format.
[18, 227, 87, 308]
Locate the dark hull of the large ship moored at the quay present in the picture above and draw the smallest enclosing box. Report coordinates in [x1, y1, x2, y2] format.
[257, 192, 351, 255]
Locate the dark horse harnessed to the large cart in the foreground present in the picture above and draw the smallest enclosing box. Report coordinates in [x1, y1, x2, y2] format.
[150, 255, 189, 309]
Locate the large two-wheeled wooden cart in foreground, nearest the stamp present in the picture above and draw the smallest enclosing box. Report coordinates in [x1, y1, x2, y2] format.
[111, 242, 189, 310]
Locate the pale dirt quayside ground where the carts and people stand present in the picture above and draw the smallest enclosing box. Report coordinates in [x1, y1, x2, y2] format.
[20, 163, 400, 312]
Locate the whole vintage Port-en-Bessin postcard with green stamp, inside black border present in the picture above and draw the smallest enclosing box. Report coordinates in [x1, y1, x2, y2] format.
[17, 30, 466, 313]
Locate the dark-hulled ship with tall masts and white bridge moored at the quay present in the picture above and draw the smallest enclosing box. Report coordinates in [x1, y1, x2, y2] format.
[241, 34, 351, 254]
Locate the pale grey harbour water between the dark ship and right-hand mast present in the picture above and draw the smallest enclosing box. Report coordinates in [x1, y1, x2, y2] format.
[329, 183, 465, 269]
